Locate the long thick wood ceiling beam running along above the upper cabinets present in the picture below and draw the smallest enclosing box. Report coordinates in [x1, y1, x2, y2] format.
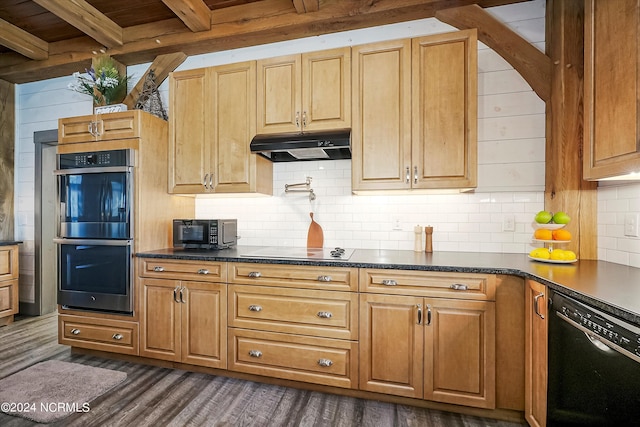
[0, 0, 524, 83]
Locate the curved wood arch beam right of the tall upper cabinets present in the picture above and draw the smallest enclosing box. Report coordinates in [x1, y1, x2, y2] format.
[436, 4, 551, 102]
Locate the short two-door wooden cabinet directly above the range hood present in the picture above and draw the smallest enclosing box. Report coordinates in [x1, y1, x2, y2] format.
[257, 47, 351, 134]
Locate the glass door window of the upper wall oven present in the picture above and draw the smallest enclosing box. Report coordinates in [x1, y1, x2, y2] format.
[59, 172, 131, 239]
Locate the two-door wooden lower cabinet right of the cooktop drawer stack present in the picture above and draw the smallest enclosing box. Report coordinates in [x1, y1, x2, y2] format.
[360, 294, 495, 409]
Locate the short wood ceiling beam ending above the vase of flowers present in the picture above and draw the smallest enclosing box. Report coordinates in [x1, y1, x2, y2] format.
[33, 0, 122, 48]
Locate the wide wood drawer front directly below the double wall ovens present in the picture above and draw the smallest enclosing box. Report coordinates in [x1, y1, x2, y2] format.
[58, 315, 138, 355]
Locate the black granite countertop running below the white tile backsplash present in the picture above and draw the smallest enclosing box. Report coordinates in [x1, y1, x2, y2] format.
[136, 246, 640, 326]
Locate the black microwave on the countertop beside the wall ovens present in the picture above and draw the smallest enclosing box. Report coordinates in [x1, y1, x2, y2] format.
[173, 219, 238, 249]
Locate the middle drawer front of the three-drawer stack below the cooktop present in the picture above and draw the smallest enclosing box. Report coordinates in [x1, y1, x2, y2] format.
[228, 285, 358, 340]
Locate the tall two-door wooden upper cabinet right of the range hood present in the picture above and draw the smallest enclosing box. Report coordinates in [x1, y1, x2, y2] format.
[352, 30, 477, 191]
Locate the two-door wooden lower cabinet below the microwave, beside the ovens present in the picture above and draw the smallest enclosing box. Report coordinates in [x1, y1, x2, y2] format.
[139, 278, 227, 369]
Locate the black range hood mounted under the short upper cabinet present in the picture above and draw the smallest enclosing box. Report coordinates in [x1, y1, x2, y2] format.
[251, 129, 351, 162]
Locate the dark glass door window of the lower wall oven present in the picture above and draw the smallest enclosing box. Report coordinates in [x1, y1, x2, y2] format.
[59, 244, 131, 295]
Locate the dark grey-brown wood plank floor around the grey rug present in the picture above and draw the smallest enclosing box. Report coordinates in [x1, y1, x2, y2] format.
[0, 314, 521, 427]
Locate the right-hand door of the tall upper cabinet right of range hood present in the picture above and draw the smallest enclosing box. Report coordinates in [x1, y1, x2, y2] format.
[411, 30, 478, 188]
